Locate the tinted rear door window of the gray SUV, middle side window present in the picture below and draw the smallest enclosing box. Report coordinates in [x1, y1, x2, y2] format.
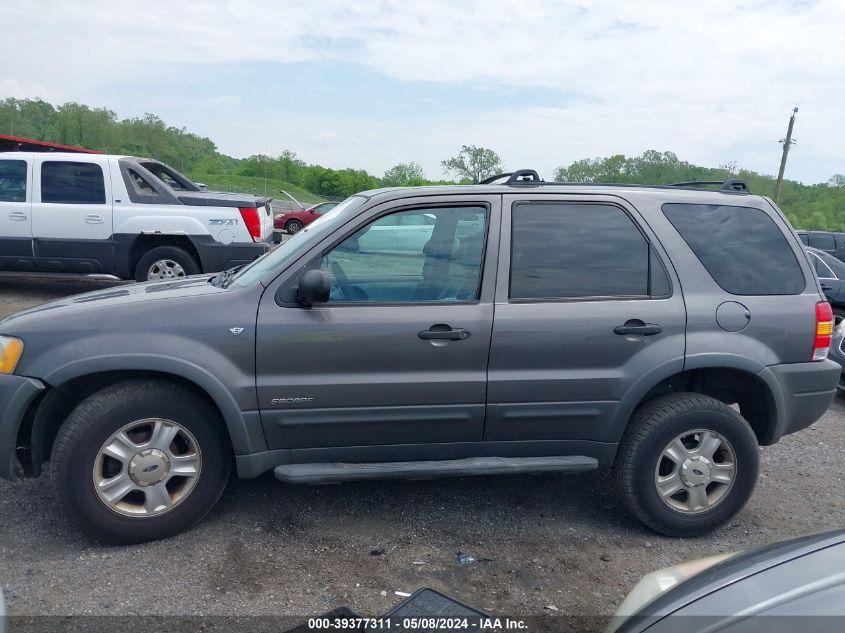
[510, 203, 669, 299]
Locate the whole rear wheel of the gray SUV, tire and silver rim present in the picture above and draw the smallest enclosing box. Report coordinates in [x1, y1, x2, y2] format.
[614, 393, 759, 537]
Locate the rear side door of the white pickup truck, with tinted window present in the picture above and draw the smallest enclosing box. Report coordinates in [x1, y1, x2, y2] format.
[32, 154, 114, 274]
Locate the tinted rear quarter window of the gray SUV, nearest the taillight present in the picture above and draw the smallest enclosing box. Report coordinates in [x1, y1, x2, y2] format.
[663, 204, 806, 295]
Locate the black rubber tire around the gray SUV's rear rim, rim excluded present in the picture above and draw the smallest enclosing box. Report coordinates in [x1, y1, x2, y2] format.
[614, 393, 759, 537]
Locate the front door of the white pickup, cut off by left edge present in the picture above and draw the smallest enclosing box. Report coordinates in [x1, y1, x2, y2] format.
[0, 156, 35, 270]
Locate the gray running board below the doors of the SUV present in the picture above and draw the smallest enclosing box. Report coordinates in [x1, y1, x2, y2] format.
[274, 455, 599, 484]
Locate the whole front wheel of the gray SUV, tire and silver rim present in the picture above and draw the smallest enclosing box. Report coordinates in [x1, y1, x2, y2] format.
[50, 380, 232, 544]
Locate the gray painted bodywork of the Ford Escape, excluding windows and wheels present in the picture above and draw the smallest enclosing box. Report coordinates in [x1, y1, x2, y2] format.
[0, 180, 839, 476]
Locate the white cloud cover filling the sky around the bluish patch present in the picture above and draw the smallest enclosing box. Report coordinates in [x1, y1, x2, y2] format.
[0, 0, 845, 180]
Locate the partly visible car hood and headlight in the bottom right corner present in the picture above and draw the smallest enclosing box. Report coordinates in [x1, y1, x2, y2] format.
[605, 530, 845, 633]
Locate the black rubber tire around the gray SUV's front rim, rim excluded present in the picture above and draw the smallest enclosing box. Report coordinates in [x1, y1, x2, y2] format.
[50, 380, 232, 544]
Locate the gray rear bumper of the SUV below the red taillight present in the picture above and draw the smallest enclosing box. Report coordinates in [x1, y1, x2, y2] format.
[761, 360, 842, 444]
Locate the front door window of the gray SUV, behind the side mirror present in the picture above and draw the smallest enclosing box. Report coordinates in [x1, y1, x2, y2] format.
[321, 207, 487, 303]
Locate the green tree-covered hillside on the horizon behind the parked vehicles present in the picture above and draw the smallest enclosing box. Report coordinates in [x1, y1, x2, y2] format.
[0, 99, 845, 230]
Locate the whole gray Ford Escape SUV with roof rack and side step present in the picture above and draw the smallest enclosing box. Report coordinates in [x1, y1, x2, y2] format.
[0, 172, 840, 543]
